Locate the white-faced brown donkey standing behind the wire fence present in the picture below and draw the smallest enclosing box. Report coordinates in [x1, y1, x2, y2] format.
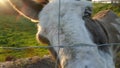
[9, 0, 120, 68]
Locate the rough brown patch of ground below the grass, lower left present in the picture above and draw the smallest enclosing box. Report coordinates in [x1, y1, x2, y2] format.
[0, 56, 55, 68]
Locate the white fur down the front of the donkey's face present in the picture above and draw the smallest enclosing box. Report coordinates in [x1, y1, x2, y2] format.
[38, 0, 114, 68]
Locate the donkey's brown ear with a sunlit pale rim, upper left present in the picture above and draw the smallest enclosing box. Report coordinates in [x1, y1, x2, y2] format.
[8, 0, 48, 22]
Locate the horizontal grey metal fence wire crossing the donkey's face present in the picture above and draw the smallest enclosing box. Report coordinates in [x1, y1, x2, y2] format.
[0, 43, 120, 50]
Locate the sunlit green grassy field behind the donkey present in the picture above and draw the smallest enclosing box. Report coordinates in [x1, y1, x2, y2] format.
[0, 4, 120, 61]
